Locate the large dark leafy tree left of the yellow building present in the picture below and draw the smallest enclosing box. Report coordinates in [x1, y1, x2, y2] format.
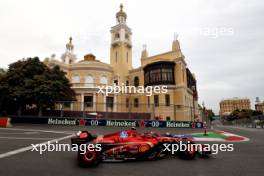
[0, 57, 75, 116]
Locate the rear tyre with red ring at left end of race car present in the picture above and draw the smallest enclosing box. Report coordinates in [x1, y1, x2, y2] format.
[77, 150, 101, 167]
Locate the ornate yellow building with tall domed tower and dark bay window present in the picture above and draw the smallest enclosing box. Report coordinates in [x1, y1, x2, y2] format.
[44, 5, 198, 121]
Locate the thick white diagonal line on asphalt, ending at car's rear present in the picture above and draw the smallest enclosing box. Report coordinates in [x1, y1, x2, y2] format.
[0, 134, 75, 159]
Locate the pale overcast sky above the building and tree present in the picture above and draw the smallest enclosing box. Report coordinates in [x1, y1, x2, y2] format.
[0, 0, 264, 113]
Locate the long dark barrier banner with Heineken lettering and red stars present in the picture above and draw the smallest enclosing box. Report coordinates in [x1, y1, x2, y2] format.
[11, 117, 203, 128]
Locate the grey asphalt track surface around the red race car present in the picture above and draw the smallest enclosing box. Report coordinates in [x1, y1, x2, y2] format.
[0, 125, 264, 176]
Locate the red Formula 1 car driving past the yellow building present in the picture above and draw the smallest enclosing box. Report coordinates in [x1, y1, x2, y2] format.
[71, 129, 211, 167]
